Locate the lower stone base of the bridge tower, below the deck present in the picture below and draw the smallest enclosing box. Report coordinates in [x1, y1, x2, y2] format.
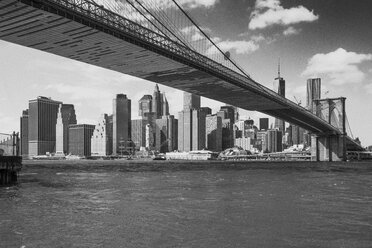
[311, 135, 346, 161]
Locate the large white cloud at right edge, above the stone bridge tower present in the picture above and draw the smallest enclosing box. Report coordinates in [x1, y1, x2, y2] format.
[302, 48, 372, 85]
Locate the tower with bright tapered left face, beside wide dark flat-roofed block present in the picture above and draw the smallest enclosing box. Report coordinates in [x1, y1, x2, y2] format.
[56, 104, 77, 154]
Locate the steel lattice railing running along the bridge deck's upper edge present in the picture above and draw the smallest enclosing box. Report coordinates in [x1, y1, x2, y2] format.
[48, 0, 294, 102]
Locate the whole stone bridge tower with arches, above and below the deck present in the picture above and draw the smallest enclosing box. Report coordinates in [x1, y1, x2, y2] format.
[311, 97, 347, 161]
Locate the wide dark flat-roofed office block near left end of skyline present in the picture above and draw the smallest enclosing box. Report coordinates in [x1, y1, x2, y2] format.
[28, 96, 61, 156]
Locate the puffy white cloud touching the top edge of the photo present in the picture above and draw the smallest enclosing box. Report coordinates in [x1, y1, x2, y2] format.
[248, 0, 319, 30]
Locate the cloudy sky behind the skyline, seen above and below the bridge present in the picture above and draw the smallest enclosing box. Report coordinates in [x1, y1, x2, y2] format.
[0, 0, 372, 146]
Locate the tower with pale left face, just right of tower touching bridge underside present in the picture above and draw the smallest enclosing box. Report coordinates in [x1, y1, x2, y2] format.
[192, 107, 212, 151]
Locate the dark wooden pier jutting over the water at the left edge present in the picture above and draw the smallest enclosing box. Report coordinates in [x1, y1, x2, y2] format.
[0, 156, 22, 186]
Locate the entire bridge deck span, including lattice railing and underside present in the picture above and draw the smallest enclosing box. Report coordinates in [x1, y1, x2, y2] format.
[0, 0, 360, 150]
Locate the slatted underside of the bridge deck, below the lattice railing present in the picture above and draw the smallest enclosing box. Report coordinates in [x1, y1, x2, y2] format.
[0, 0, 364, 151]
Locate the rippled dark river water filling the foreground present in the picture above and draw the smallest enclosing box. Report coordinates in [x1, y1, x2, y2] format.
[0, 162, 372, 248]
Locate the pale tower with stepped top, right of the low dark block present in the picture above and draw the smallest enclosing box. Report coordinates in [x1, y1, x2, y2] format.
[91, 114, 112, 156]
